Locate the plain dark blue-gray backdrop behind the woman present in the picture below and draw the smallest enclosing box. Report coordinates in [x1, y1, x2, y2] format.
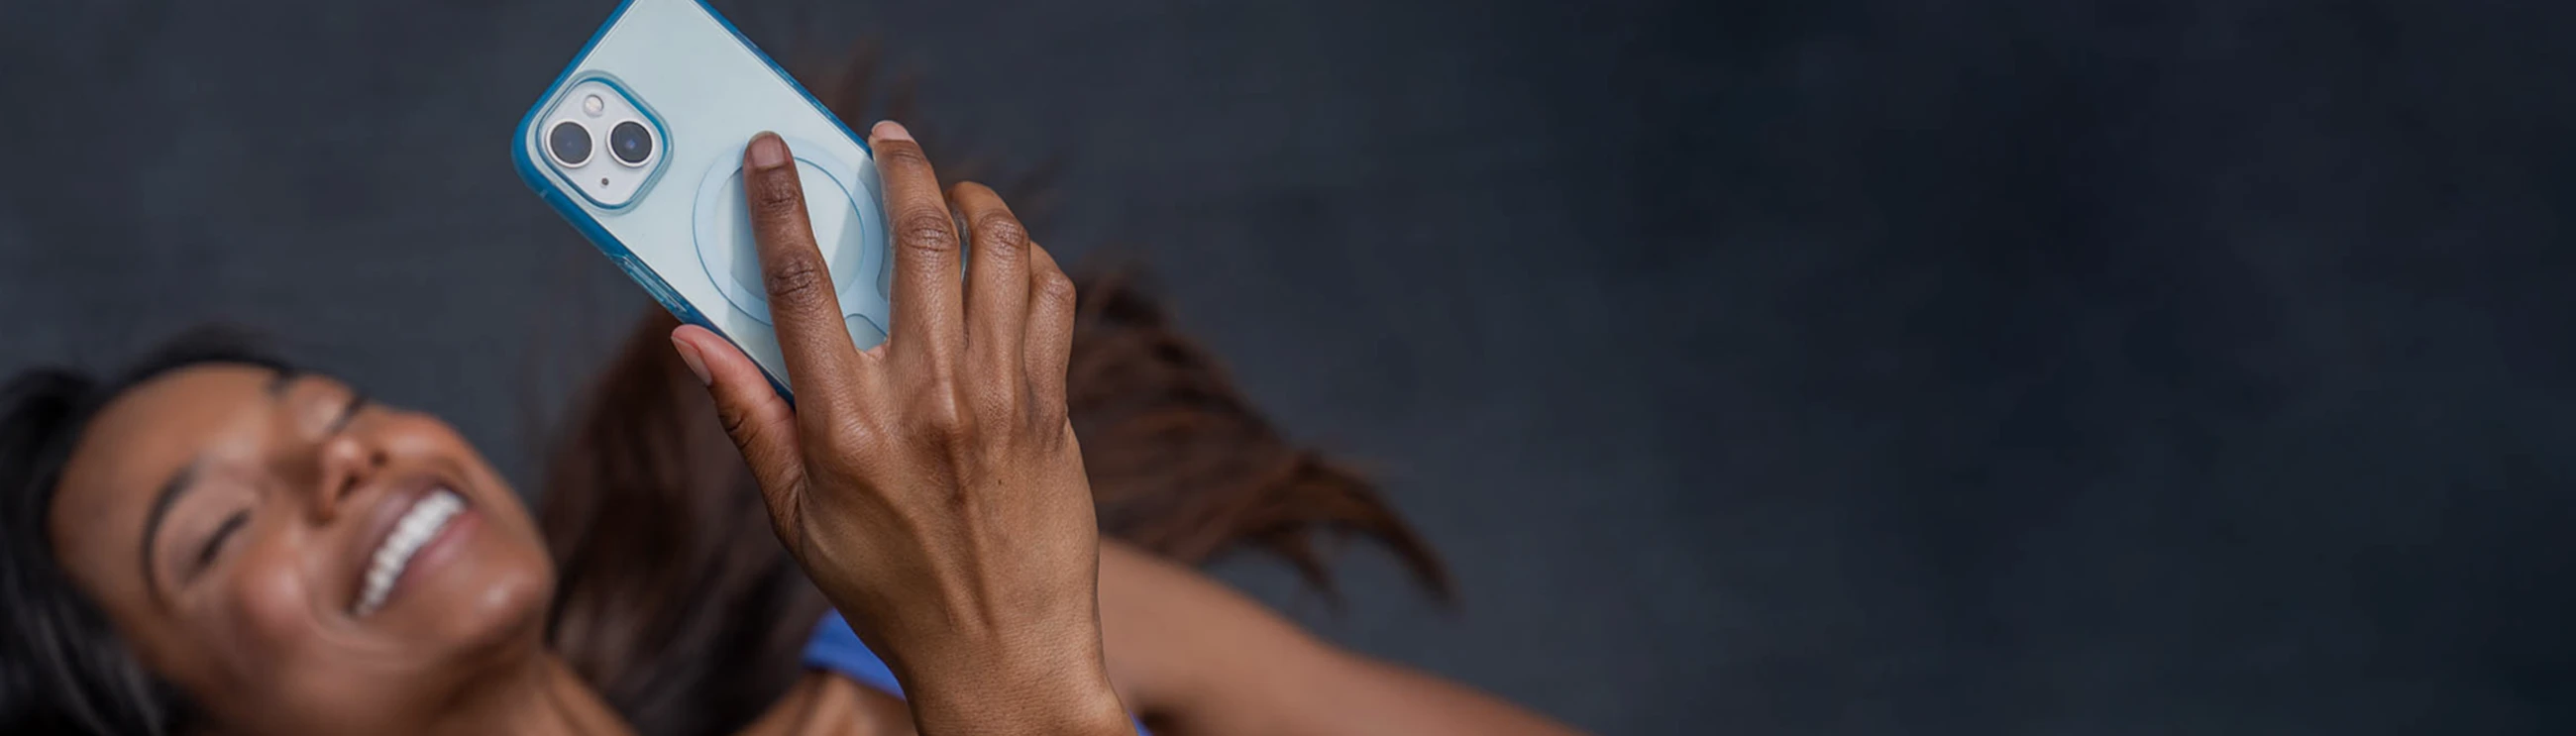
[0, 0, 2576, 733]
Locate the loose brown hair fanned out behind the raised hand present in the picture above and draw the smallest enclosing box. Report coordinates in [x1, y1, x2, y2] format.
[538, 49, 1450, 736]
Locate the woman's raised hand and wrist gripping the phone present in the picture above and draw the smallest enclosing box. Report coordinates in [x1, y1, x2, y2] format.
[673, 121, 1128, 733]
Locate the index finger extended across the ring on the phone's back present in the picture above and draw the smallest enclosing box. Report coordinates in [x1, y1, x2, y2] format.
[742, 134, 858, 409]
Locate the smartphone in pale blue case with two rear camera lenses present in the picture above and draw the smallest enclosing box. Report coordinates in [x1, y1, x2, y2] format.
[510, 0, 892, 399]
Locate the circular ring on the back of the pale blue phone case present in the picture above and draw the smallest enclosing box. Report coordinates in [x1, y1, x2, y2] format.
[693, 137, 892, 342]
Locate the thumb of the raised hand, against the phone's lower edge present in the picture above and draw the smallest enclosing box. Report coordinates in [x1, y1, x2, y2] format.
[670, 324, 806, 522]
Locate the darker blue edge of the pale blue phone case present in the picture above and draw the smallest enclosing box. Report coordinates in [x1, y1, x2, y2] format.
[510, 0, 876, 406]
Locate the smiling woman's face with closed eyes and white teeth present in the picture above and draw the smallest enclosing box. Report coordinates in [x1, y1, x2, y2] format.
[49, 363, 554, 733]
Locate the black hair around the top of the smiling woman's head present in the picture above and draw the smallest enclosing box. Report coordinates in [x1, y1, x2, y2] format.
[0, 330, 288, 733]
